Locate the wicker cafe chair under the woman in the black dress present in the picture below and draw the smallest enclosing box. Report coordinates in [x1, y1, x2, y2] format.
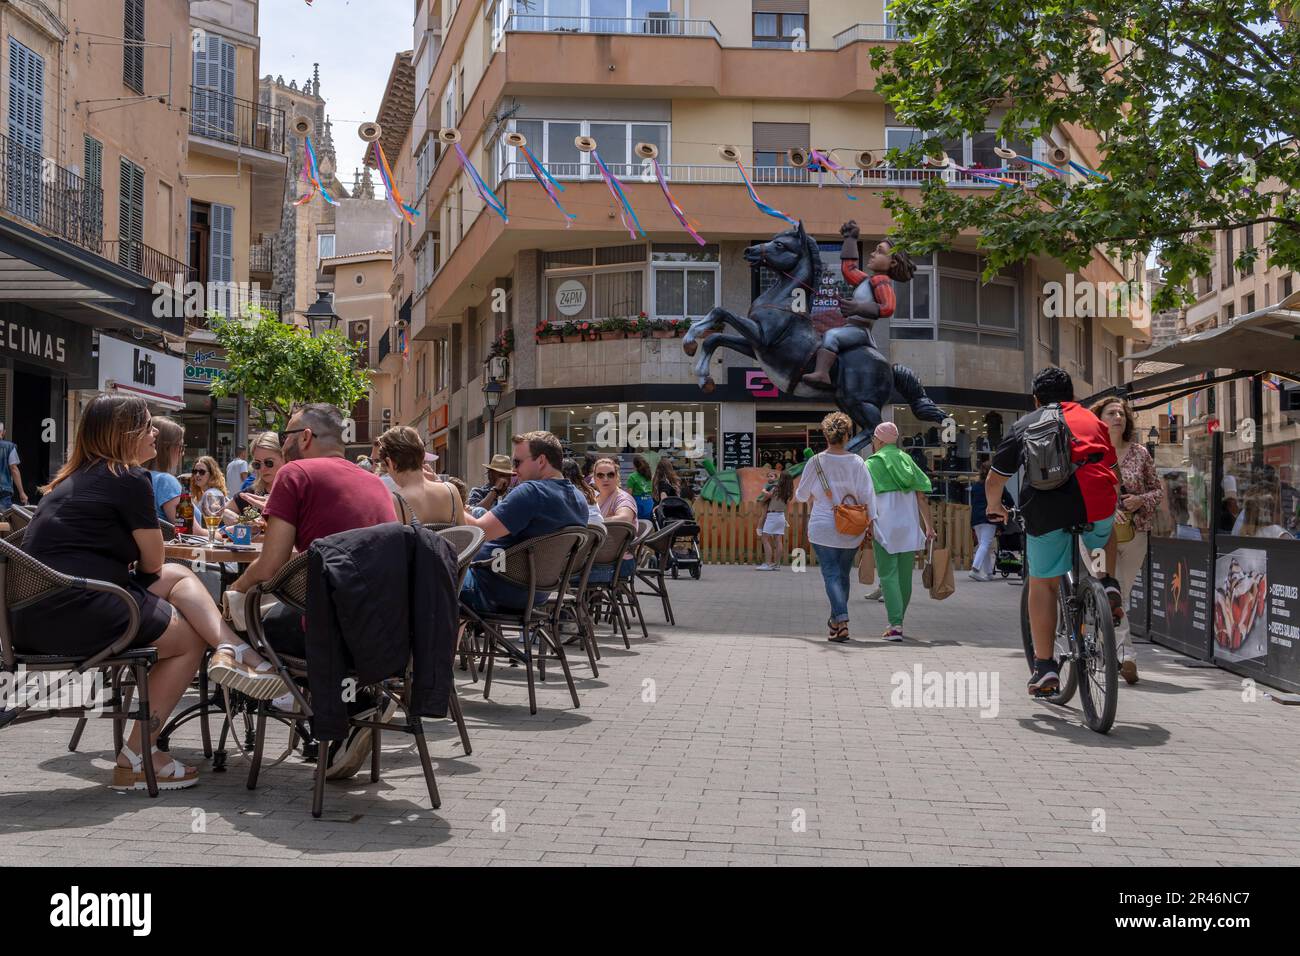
[0, 541, 159, 797]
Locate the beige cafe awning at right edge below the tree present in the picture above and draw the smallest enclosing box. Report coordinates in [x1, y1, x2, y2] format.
[1125, 291, 1300, 374]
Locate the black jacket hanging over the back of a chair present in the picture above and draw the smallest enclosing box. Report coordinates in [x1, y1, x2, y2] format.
[307, 522, 460, 740]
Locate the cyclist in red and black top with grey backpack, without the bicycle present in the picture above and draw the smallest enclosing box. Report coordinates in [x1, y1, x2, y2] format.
[984, 365, 1122, 695]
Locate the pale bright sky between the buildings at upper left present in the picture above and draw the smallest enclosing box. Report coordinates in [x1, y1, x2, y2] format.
[257, 0, 415, 189]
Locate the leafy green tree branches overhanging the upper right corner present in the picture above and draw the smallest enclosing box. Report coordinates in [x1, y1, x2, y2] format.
[872, 0, 1300, 308]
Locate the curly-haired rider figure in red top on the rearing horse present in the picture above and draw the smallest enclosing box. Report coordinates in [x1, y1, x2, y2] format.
[803, 220, 917, 388]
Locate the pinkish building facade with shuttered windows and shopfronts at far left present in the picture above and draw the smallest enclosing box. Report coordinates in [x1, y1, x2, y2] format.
[0, 0, 191, 493]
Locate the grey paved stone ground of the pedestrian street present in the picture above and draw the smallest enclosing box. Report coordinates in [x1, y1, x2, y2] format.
[0, 567, 1300, 866]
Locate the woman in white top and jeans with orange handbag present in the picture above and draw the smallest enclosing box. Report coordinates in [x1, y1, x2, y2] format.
[794, 411, 871, 644]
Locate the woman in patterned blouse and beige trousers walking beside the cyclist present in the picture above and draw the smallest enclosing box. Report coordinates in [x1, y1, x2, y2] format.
[1092, 398, 1165, 684]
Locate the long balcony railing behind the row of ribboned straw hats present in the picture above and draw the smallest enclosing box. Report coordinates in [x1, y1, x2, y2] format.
[502, 163, 1034, 189]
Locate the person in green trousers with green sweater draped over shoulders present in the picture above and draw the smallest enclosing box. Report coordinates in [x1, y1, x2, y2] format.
[867, 421, 935, 641]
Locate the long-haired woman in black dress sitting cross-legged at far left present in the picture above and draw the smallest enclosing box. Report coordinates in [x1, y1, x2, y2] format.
[13, 394, 285, 790]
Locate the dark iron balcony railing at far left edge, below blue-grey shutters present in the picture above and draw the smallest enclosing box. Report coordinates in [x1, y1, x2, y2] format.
[0, 133, 104, 252]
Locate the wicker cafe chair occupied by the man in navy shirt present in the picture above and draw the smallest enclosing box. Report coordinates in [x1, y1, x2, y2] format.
[462, 525, 590, 714]
